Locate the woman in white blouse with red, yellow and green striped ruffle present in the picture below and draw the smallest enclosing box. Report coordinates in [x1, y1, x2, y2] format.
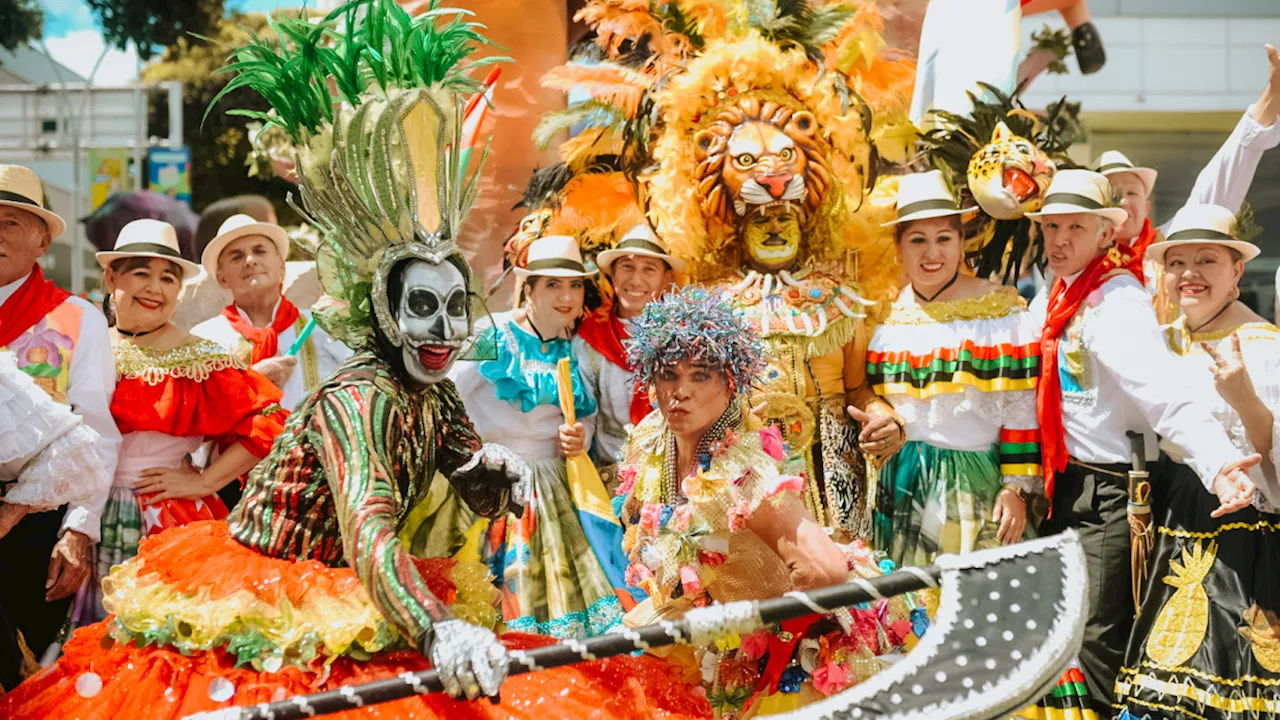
[867, 170, 1043, 565]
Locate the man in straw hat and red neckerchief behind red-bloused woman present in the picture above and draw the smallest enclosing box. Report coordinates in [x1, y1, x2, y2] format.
[192, 214, 351, 410]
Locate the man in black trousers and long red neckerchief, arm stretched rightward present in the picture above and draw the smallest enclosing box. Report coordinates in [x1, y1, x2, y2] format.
[1029, 170, 1261, 716]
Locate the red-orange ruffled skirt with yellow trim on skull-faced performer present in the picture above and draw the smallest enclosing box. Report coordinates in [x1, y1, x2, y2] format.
[0, 523, 712, 720]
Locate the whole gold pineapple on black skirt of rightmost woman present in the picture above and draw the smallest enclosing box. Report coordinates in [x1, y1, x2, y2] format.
[1147, 539, 1217, 665]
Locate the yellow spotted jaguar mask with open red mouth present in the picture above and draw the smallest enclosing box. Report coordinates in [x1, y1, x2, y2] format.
[968, 123, 1056, 220]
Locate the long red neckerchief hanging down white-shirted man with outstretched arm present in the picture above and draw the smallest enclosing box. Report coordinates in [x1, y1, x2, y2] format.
[1036, 242, 1142, 510]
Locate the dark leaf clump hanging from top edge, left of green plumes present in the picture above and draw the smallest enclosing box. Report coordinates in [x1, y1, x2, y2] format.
[87, 0, 223, 60]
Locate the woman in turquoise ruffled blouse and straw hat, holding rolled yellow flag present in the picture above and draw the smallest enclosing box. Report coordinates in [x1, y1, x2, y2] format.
[451, 236, 623, 637]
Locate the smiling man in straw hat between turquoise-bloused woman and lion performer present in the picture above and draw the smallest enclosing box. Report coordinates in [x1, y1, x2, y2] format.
[573, 222, 685, 479]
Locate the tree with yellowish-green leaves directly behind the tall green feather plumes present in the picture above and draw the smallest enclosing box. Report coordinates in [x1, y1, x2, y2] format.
[142, 10, 300, 224]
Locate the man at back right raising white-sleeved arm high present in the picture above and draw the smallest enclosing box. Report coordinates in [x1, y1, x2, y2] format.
[1094, 45, 1280, 256]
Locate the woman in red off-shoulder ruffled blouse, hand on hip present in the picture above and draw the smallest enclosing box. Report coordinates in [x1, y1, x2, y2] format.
[97, 220, 288, 604]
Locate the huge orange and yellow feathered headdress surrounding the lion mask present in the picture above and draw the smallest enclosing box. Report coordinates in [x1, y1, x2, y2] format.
[524, 0, 916, 302]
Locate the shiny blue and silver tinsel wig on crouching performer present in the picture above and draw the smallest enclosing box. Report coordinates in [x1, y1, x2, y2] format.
[627, 286, 764, 393]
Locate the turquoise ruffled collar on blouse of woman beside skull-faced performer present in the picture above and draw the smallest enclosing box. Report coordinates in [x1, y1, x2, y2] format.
[477, 322, 595, 418]
